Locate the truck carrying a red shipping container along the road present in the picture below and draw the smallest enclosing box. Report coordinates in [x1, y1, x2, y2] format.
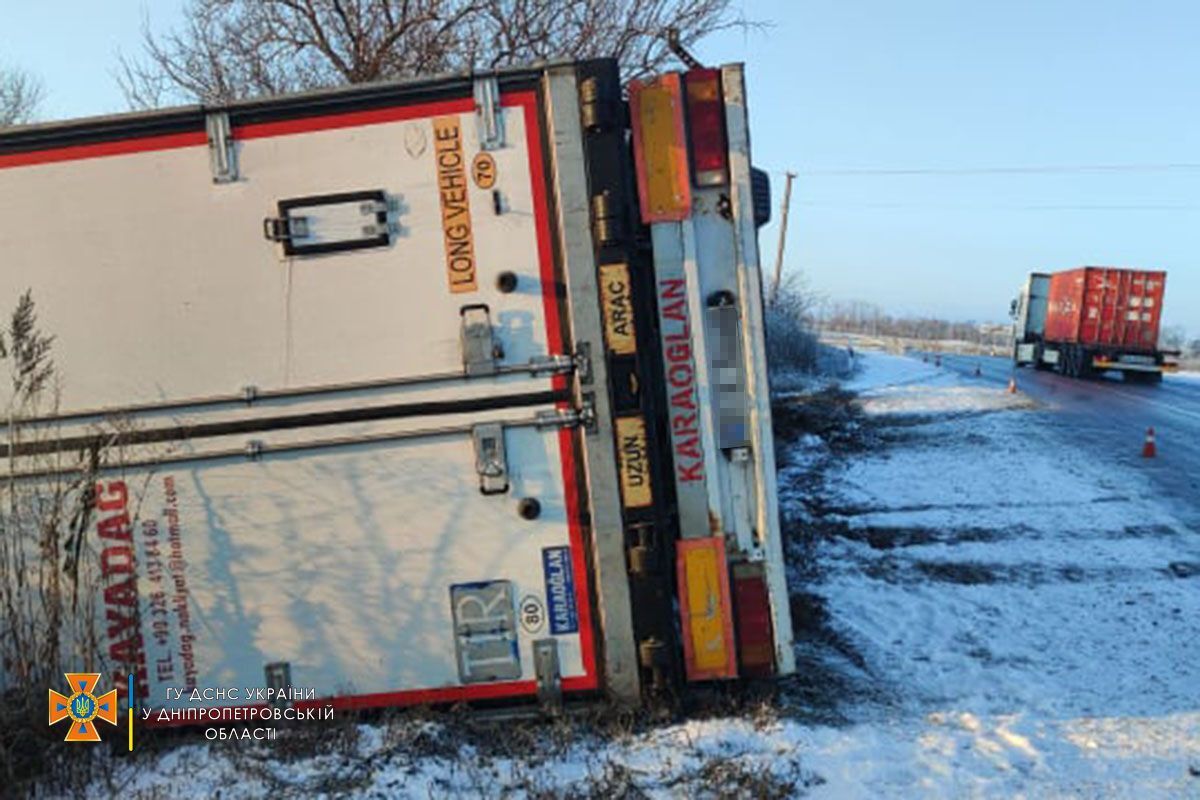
[1013, 266, 1175, 383]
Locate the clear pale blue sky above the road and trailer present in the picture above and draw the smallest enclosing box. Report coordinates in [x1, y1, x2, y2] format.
[0, 0, 1200, 335]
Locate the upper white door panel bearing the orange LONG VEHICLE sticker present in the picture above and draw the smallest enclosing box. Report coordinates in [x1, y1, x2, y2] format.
[0, 94, 558, 411]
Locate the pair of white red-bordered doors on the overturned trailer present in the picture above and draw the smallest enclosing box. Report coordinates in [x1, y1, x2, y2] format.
[0, 77, 598, 708]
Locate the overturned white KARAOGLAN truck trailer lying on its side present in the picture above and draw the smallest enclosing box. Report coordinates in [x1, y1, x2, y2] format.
[0, 60, 793, 721]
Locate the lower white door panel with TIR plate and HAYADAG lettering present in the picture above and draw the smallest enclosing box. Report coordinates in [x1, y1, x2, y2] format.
[97, 428, 594, 708]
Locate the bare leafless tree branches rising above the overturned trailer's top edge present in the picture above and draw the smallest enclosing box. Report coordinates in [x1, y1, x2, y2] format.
[119, 0, 748, 108]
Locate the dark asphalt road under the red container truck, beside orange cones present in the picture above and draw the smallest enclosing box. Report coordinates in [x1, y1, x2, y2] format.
[918, 354, 1200, 533]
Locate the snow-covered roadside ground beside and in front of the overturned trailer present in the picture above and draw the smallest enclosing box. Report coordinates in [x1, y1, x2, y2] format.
[49, 354, 1200, 799]
